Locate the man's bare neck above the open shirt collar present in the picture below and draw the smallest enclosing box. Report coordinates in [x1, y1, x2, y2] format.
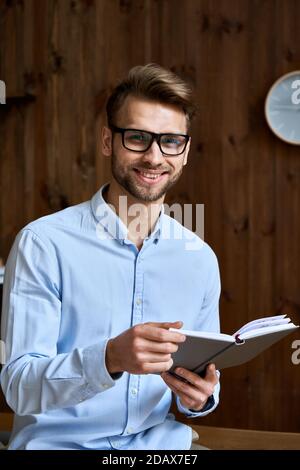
[103, 178, 164, 249]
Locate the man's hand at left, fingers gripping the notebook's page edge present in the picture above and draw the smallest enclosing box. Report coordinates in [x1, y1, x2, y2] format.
[106, 321, 185, 374]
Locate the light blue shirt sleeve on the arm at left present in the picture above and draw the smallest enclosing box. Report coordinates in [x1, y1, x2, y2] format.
[1, 229, 119, 415]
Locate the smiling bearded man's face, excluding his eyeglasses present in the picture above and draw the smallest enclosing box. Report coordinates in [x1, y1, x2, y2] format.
[103, 96, 190, 202]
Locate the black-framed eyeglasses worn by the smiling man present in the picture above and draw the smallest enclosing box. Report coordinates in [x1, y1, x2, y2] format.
[110, 125, 190, 157]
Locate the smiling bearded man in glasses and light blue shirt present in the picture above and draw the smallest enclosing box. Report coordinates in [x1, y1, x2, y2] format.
[1, 64, 220, 450]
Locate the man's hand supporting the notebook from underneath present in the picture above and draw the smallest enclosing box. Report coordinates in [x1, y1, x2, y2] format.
[161, 364, 219, 411]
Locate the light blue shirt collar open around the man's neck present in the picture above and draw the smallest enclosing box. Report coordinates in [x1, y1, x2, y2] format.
[91, 183, 164, 243]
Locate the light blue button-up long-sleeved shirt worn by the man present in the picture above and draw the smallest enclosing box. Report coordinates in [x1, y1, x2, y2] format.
[1, 185, 220, 450]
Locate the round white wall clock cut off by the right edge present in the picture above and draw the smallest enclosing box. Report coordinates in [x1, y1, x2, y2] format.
[265, 71, 300, 145]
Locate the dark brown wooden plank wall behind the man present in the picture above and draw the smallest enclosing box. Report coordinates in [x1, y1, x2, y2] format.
[0, 0, 300, 432]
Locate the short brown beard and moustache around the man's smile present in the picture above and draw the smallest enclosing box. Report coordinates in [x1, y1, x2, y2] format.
[111, 153, 183, 202]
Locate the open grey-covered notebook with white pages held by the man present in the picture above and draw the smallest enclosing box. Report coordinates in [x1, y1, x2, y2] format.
[170, 315, 299, 373]
